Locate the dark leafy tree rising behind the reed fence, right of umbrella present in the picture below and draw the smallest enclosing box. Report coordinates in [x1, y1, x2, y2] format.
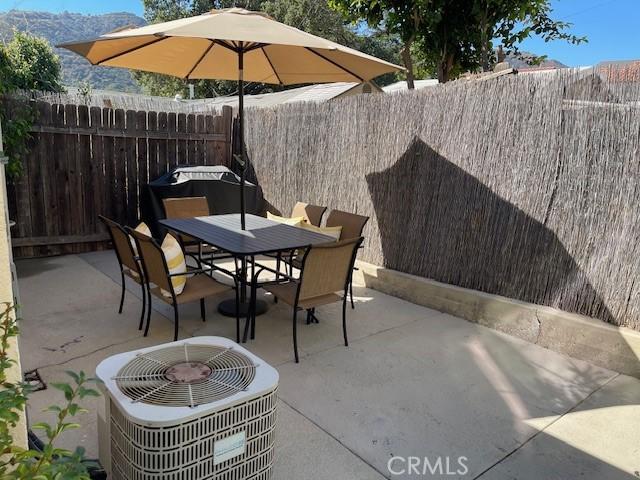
[329, 0, 586, 82]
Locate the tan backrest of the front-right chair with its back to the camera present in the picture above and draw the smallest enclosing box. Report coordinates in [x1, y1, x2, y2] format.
[299, 237, 364, 300]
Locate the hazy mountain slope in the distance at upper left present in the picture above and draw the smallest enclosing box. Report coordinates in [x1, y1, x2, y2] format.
[0, 10, 145, 92]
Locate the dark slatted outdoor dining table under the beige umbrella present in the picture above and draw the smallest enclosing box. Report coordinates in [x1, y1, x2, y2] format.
[160, 213, 335, 324]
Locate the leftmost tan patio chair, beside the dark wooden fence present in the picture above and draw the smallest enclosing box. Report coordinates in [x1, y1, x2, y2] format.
[98, 215, 150, 330]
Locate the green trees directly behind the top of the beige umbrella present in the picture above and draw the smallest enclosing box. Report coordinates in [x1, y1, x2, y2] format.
[134, 0, 399, 98]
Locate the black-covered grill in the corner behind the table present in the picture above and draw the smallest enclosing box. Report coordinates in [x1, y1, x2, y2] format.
[140, 165, 264, 238]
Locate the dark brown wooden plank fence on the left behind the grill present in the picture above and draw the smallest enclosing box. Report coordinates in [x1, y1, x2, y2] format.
[8, 102, 232, 257]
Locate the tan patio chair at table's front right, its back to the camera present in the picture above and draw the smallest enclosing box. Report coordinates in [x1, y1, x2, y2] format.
[248, 237, 364, 363]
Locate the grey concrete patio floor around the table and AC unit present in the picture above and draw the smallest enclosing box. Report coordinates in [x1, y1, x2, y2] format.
[17, 251, 640, 480]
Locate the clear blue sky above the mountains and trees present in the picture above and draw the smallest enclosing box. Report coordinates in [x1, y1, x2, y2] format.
[0, 0, 640, 66]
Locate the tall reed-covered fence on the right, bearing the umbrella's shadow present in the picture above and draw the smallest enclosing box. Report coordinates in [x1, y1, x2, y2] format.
[246, 72, 640, 329]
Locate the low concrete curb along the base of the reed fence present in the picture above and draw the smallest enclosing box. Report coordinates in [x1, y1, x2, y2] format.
[354, 261, 640, 378]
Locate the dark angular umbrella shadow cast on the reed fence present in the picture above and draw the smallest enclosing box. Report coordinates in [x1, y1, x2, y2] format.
[366, 138, 615, 323]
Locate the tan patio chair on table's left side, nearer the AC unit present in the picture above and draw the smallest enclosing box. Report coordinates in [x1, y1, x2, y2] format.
[127, 229, 240, 342]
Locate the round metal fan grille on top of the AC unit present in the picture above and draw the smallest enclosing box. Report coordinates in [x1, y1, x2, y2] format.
[114, 343, 256, 407]
